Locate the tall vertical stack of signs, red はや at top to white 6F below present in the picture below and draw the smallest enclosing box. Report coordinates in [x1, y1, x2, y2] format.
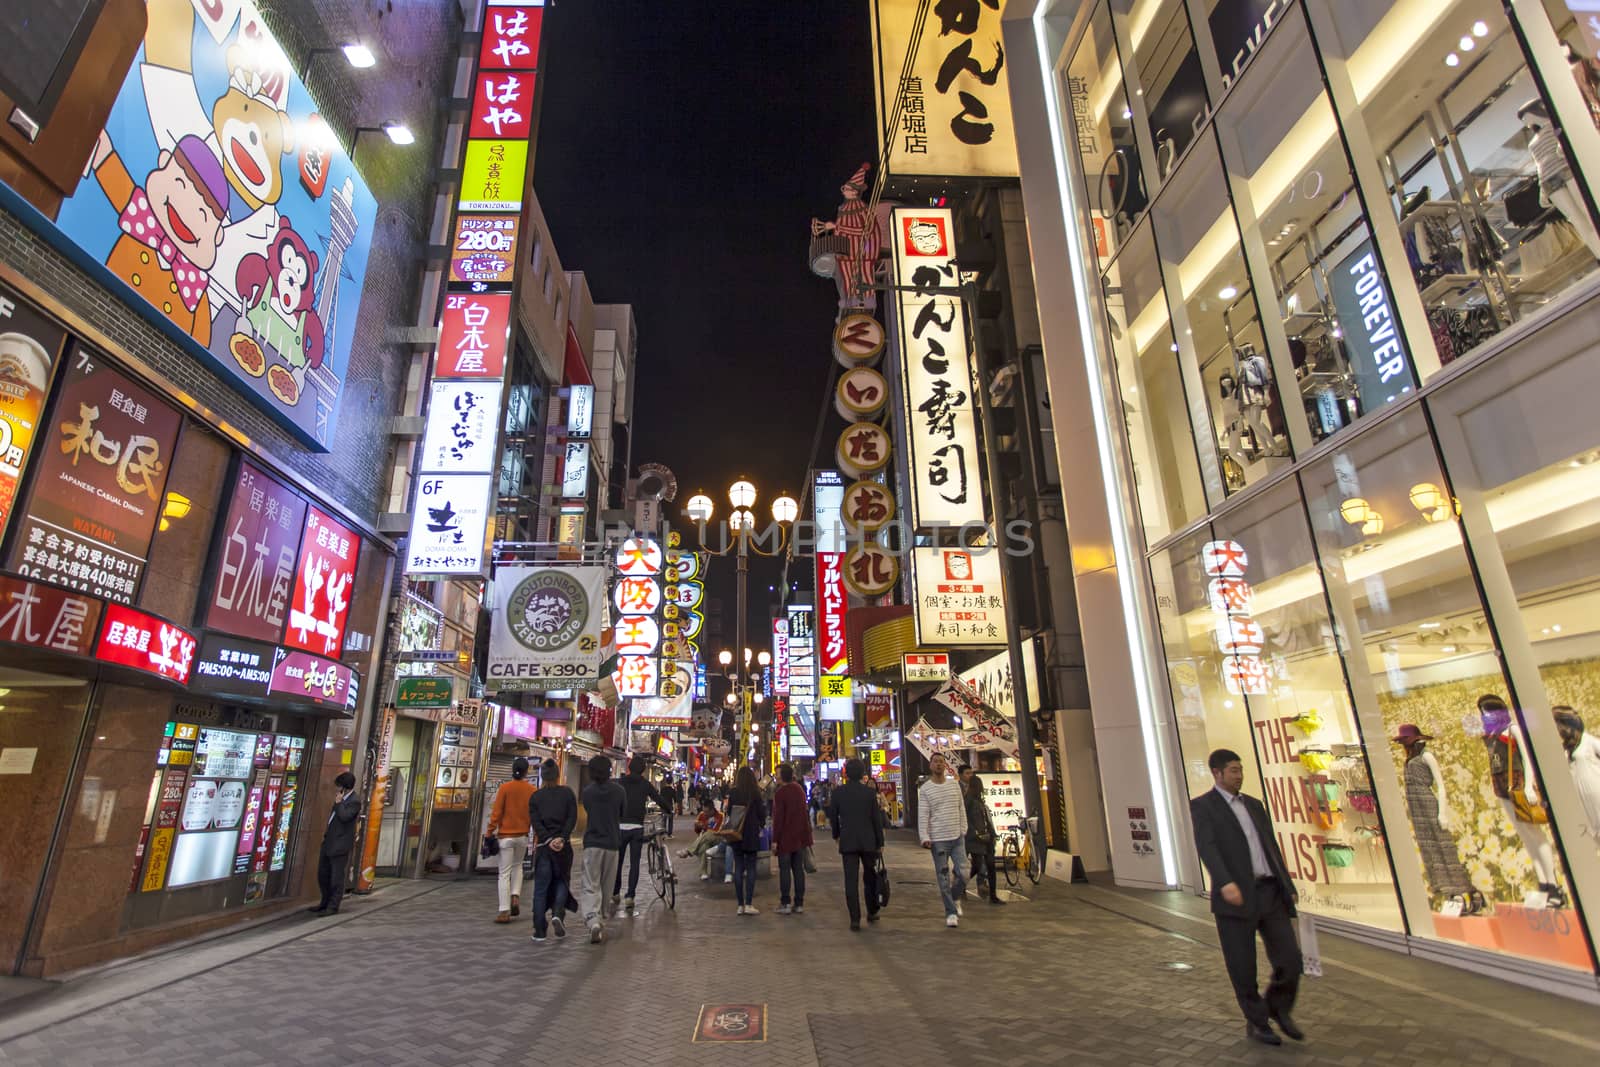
[405, 0, 544, 576]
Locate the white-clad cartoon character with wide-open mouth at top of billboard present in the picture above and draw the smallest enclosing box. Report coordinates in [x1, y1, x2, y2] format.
[139, 0, 294, 321]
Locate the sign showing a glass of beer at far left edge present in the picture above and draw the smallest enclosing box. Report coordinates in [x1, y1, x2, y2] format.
[0, 285, 66, 536]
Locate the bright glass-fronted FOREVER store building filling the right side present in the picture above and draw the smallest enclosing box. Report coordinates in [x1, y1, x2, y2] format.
[1005, 0, 1600, 998]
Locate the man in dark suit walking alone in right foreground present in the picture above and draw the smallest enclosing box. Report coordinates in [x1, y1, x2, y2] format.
[1189, 749, 1306, 1045]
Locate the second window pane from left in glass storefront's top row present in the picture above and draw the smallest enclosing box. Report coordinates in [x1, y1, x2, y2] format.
[1110, 0, 1211, 181]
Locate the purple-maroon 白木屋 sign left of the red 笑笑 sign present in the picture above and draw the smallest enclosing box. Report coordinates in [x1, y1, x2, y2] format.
[205, 461, 307, 641]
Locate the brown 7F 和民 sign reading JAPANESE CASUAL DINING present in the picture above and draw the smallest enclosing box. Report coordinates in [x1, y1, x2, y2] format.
[10, 347, 182, 603]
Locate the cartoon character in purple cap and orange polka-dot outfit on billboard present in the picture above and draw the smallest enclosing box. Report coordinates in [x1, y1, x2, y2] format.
[90, 131, 227, 344]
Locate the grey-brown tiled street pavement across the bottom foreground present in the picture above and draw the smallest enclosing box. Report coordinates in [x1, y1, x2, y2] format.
[0, 845, 1600, 1067]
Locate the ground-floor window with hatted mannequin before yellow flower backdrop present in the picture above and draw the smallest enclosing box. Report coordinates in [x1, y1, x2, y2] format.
[1302, 410, 1590, 969]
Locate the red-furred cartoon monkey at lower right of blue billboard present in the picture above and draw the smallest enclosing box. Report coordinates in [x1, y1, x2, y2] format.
[234, 218, 323, 381]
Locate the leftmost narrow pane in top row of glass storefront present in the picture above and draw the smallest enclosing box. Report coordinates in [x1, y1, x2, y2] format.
[1067, 6, 1150, 267]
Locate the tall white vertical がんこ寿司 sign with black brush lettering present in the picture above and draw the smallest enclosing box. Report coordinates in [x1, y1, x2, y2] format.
[891, 208, 984, 528]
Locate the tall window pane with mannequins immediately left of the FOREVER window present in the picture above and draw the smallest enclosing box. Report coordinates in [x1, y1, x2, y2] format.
[1152, 134, 1290, 493]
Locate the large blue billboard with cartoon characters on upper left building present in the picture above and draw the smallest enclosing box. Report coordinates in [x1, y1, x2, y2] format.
[56, 0, 378, 450]
